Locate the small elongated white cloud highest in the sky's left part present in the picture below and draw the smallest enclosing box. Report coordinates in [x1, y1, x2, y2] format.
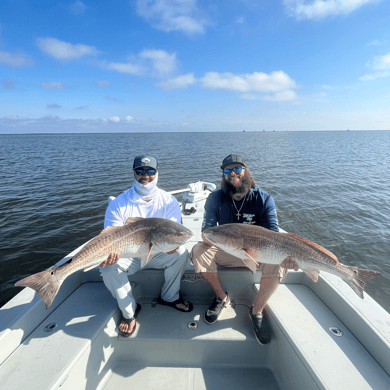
[37, 38, 100, 61]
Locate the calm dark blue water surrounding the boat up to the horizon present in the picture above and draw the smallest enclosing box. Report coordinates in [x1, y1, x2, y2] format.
[0, 131, 390, 311]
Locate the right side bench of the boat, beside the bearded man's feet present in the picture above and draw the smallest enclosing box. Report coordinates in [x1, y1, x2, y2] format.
[266, 284, 390, 390]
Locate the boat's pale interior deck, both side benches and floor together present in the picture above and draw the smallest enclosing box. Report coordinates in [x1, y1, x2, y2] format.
[0, 282, 390, 390]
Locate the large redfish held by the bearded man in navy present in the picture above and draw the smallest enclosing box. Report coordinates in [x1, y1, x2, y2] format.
[203, 223, 380, 299]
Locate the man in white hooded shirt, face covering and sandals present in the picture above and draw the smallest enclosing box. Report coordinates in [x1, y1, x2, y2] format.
[100, 155, 193, 337]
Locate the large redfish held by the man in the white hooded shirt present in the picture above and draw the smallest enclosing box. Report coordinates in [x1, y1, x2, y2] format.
[15, 218, 193, 309]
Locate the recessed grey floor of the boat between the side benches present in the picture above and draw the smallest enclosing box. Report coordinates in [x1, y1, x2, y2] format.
[99, 303, 279, 390]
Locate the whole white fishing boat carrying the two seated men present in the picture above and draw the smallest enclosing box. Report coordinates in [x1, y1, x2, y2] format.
[0, 182, 390, 390]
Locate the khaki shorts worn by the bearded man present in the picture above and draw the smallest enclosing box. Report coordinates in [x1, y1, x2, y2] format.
[191, 242, 287, 279]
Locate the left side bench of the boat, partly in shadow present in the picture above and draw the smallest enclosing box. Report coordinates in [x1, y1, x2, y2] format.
[0, 282, 119, 390]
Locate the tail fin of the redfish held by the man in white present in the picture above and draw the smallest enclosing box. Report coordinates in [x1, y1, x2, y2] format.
[15, 268, 62, 309]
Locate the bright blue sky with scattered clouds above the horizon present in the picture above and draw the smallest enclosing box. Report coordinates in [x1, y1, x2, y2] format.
[0, 0, 390, 134]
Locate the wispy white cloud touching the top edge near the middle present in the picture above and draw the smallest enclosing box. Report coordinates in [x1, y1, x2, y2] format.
[137, 0, 210, 35]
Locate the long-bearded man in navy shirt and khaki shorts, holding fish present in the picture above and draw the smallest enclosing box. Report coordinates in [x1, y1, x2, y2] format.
[191, 155, 298, 345]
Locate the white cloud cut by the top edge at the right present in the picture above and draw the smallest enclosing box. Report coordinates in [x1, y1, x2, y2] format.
[284, 0, 378, 19]
